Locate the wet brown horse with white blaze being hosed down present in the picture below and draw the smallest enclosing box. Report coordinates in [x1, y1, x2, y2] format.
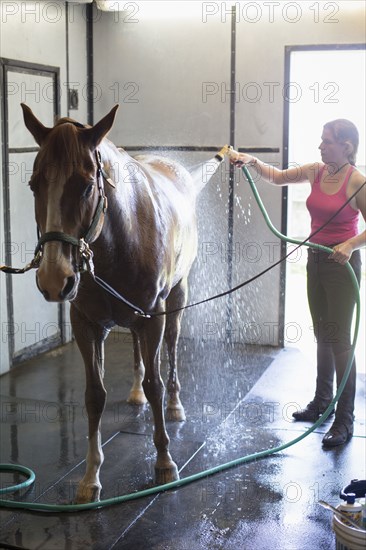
[22, 105, 222, 503]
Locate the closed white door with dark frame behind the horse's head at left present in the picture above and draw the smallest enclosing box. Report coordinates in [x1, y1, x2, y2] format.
[1, 59, 64, 364]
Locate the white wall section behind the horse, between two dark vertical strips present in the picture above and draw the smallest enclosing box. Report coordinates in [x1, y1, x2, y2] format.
[94, 6, 230, 348]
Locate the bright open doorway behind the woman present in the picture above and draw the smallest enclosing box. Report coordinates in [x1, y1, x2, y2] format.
[284, 44, 366, 372]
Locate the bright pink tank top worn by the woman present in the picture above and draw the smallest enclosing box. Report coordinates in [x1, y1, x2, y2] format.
[306, 166, 359, 246]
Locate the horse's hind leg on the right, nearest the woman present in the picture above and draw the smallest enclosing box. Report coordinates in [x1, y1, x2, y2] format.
[164, 279, 187, 422]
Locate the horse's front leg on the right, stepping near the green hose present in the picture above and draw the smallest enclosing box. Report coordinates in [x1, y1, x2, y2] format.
[139, 317, 179, 485]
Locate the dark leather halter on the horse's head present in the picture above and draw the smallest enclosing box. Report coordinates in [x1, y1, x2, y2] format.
[34, 150, 108, 273]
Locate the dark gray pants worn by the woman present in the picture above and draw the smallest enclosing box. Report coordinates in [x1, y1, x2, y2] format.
[307, 249, 361, 426]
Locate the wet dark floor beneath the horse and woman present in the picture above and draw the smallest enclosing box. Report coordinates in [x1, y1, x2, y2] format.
[0, 334, 366, 550]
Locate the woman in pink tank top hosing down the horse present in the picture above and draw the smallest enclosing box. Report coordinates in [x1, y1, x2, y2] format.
[231, 119, 366, 447]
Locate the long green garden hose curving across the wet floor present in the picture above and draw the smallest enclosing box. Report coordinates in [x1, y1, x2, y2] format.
[0, 165, 360, 513]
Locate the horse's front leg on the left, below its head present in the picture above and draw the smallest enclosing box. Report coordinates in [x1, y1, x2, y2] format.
[70, 305, 108, 504]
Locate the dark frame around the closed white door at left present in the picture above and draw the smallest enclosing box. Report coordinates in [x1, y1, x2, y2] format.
[0, 58, 65, 366]
